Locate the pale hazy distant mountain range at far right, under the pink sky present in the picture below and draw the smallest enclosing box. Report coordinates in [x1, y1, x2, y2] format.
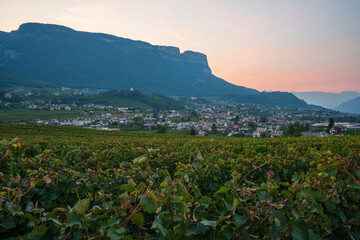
[293, 91, 360, 109]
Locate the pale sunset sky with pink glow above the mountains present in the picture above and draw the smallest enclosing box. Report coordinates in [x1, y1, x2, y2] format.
[0, 0, 360, 92]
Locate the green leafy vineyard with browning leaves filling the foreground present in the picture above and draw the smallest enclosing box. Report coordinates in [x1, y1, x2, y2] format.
[0, 124, 360, 240]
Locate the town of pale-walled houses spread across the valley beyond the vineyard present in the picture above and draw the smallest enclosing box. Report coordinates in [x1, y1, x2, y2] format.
[29, 104, 360, 138]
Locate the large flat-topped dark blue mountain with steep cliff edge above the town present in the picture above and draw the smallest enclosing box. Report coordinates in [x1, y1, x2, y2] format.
[0, 23, 257, 96]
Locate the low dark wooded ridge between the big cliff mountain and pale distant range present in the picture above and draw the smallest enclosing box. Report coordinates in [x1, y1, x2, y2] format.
[221, 91, 321, 109]
